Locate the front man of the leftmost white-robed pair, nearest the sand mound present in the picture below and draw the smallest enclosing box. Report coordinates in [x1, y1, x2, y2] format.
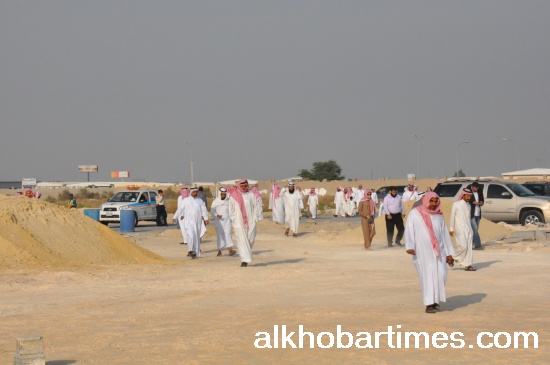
[175, 187, 208, 259]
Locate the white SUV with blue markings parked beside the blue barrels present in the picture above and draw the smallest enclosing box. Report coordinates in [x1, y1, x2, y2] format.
[99, 190, 157, 226]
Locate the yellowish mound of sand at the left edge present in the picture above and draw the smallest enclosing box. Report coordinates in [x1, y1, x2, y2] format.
[0, 195, 163, 268]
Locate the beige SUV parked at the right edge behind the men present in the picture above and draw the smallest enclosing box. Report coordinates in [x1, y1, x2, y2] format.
[434, 180, 550, 225]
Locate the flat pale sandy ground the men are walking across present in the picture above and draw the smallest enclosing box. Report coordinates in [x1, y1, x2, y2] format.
[0, 215, 550, 365]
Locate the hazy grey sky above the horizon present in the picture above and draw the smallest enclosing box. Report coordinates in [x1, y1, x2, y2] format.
[0, 0, 550, 181]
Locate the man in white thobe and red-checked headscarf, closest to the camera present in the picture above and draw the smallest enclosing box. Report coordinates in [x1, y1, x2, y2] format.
[405, 192, 454, 313]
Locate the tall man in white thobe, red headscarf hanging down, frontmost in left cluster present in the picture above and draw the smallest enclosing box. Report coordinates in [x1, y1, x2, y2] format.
[229, 179, 258, 267]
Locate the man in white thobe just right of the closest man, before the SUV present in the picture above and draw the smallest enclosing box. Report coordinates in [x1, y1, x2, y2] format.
[449, 189, 476, 271]
